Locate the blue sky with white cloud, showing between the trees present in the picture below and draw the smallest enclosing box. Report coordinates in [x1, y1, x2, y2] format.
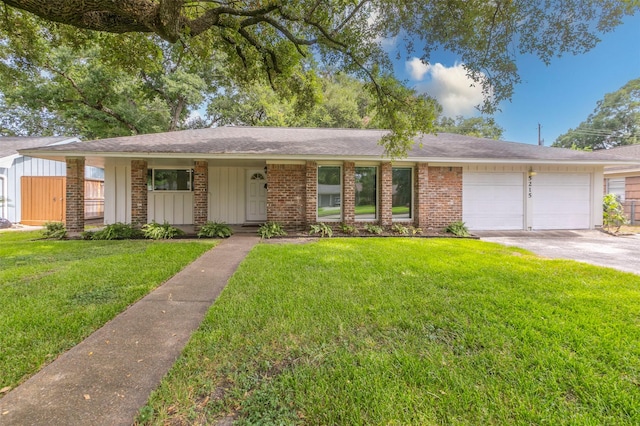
[395, 14, 640, 146]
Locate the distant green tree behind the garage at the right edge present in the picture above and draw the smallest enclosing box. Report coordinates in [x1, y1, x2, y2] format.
[553, 78, 640, 150]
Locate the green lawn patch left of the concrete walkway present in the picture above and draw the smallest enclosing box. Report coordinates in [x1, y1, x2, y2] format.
[0, 232, 215, 388]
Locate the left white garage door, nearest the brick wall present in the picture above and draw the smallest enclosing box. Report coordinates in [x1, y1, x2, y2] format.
[462, 173, 524, 231]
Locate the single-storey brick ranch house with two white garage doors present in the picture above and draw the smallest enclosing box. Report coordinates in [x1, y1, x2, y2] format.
[17, 127, 626, 232]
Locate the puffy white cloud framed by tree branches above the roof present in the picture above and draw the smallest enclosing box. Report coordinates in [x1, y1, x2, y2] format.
[406, 58, 483, 117]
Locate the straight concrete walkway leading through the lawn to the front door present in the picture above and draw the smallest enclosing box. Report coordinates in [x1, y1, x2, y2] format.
[0, 234, 258, 425]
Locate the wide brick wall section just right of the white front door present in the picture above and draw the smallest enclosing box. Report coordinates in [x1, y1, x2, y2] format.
[267, 164, 307, 228]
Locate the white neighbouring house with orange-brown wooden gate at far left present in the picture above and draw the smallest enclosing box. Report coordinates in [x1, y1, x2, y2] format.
[0, 137, 104, 225]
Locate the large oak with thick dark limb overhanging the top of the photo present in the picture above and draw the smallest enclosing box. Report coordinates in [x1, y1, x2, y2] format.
[0, 0, 639, 155]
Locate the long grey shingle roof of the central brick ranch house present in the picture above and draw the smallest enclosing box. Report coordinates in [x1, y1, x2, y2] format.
[18, 127, 636, 164]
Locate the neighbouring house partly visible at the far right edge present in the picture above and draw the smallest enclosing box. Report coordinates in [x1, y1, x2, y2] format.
[596, 144, 640, 224]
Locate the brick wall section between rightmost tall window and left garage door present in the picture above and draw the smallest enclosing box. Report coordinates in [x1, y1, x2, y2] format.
[427, 167, 462, 229]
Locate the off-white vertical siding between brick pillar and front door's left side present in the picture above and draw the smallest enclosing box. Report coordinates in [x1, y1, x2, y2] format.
[209, 167, 247, 224]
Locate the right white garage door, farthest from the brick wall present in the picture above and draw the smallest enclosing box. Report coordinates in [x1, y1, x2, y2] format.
[532, 173, 591, 229]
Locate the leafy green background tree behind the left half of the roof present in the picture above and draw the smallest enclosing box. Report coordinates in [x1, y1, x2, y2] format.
[0, 12, 224, 139]
